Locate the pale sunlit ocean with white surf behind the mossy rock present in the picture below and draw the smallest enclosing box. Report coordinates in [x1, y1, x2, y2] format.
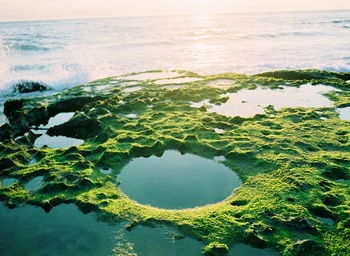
[0, 10, 350, 97]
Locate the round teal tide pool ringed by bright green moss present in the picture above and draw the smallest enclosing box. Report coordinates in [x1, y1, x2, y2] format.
[118, 150, 242, 209]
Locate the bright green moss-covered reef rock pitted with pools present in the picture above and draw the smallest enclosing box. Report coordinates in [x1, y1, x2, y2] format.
[0, 70, 350, 256]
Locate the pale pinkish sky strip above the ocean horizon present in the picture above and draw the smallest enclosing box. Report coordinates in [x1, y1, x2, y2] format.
[0, 0, 350, 21]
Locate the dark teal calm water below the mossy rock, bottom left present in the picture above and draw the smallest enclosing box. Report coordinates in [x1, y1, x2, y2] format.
[0, 204, 203, 256]
